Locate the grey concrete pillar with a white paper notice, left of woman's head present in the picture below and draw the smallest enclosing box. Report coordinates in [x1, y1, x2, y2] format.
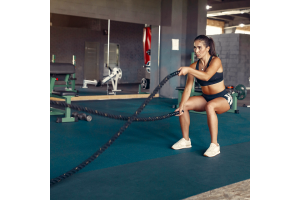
[150, 0, 207, 98]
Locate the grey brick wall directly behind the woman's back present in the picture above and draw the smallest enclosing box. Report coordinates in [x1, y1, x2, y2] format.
[210, 33, 250, 87]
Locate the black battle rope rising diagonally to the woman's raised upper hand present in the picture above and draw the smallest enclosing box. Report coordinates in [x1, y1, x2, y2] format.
[50, 71, 179, 186]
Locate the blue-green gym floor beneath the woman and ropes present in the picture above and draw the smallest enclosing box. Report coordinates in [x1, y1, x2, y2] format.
[50, 98, 250, 200]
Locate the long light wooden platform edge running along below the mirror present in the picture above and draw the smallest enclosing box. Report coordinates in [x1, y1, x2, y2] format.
[50, 94, 159, 101]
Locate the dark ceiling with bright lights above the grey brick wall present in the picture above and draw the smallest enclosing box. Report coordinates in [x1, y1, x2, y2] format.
[207, 0, 250, 27]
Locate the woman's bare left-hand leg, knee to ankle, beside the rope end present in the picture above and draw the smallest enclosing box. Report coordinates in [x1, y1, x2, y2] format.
[179, 96, 207, 140]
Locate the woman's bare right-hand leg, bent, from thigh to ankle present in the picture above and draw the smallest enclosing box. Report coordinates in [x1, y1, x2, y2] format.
[205, 97, 230, 145]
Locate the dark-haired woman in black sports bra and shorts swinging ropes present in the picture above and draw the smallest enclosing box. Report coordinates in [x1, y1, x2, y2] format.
[172, 35, 232, 157]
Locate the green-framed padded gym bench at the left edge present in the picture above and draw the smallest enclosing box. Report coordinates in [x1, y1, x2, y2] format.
[50, 63, 79, 123]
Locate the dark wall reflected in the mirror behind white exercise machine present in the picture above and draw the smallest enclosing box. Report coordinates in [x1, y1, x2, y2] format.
[50, 20, 145, 84]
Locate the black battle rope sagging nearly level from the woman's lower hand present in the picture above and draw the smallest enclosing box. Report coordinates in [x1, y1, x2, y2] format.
[50, 100, 179, 122]
